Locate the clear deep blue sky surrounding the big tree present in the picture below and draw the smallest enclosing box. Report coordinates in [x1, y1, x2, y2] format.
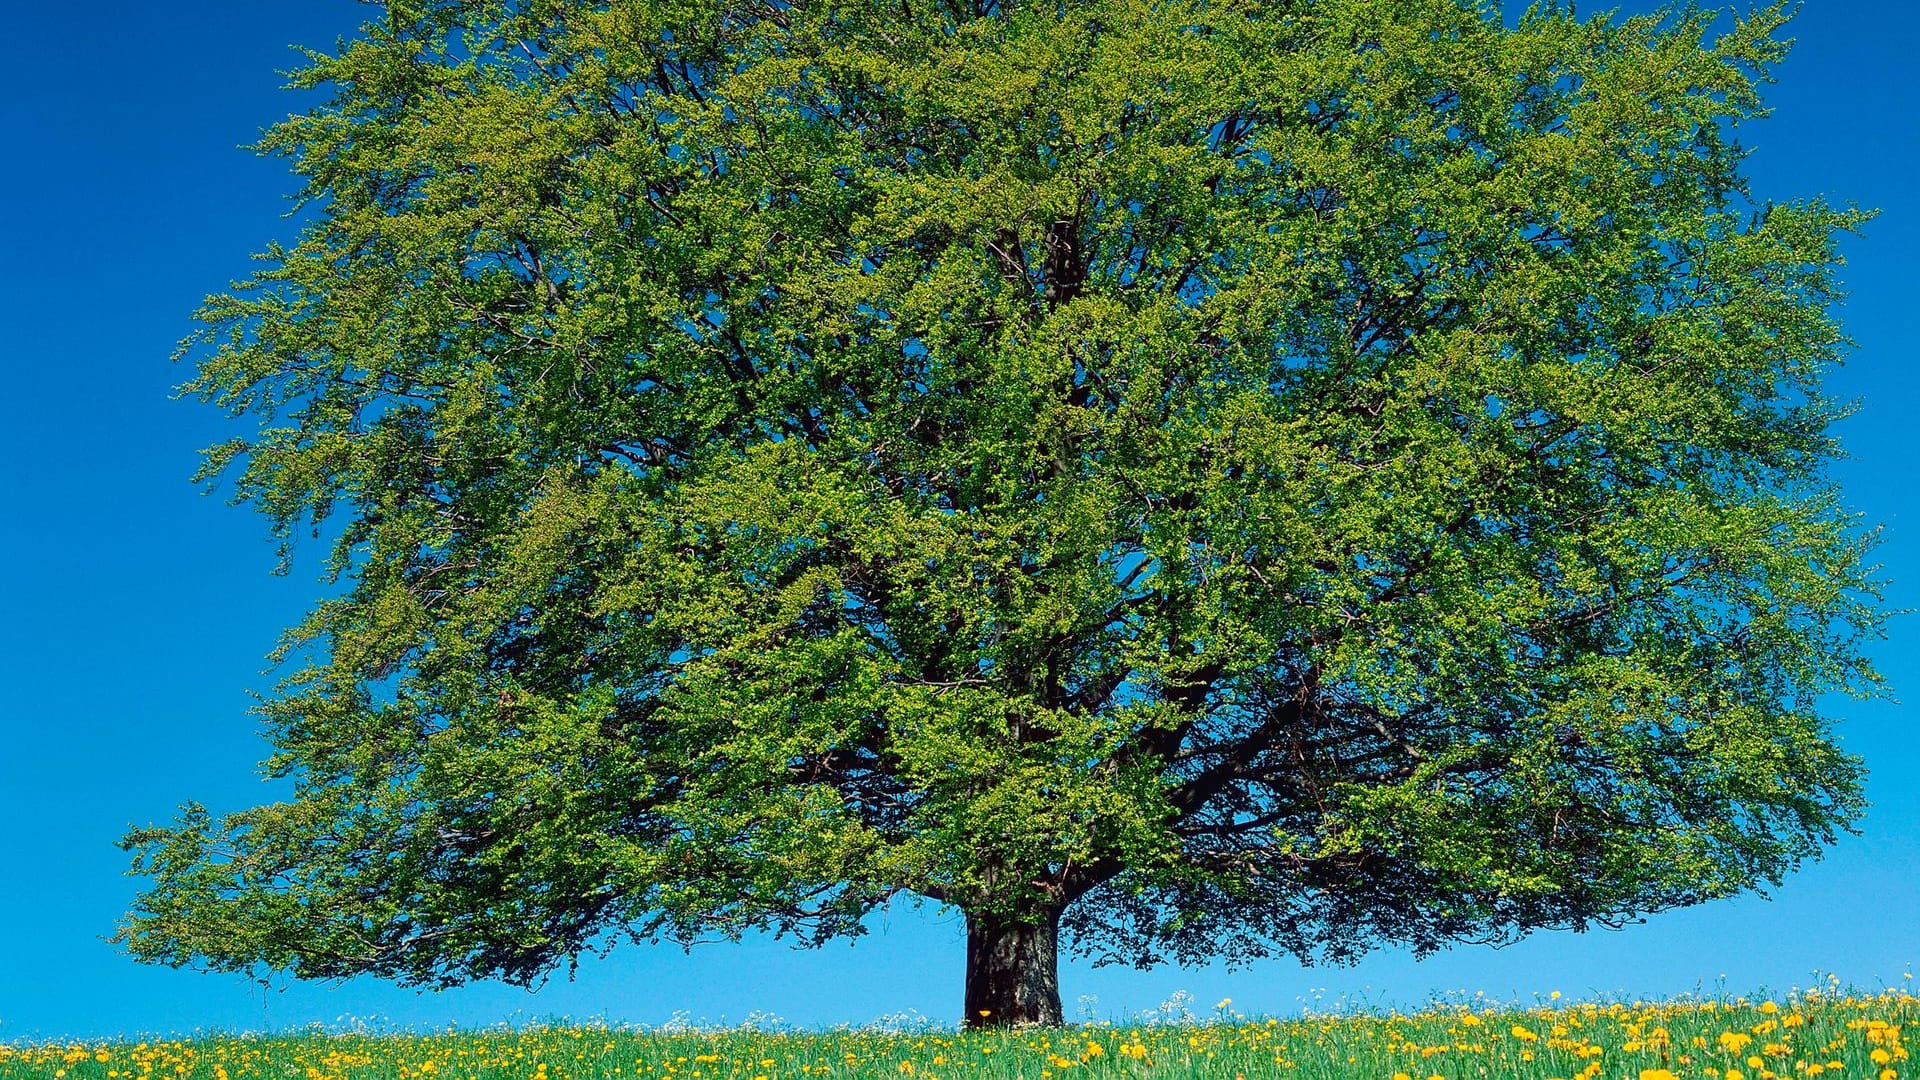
[0, 0, 1920, 1042]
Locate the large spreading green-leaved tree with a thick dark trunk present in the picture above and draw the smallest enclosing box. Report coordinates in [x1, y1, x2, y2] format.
[119, 0, 1882, 1024]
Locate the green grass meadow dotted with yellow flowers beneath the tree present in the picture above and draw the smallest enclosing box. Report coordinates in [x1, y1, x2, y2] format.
[0, 992, 1920, 1080]
